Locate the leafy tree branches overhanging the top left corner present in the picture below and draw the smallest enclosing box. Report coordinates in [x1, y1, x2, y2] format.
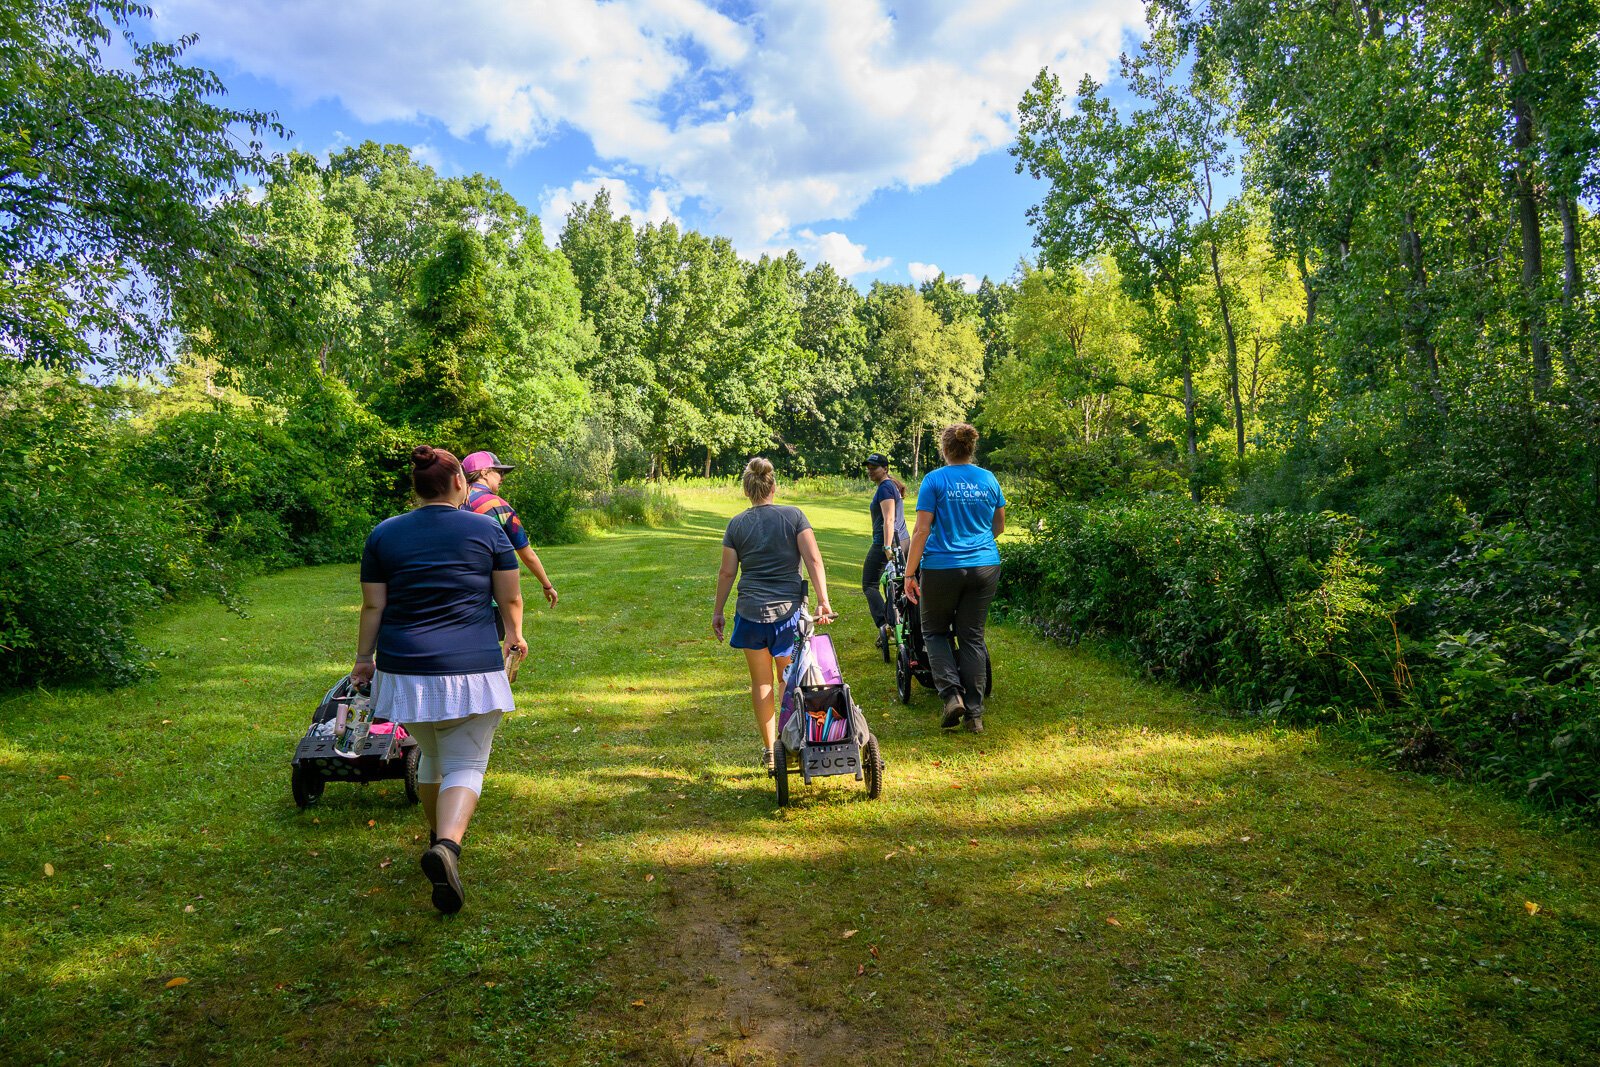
[0, 0, 282, 370]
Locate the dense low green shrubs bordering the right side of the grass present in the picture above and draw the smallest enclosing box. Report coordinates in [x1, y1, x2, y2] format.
[1000, 499, 1600, 816]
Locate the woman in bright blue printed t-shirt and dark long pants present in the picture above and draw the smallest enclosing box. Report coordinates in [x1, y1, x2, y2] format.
[906, 422, 1005, 734]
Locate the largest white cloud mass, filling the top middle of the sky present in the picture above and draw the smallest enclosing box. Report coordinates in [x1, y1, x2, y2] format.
[157, 0, 1144, 245]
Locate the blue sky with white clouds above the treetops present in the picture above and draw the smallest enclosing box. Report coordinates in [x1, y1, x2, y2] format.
[154, 0, 1142, 288]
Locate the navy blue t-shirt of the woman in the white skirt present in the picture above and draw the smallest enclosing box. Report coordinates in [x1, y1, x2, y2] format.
[362, 506, 517, 675]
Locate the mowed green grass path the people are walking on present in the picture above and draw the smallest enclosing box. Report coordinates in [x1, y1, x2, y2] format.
[0, 490, 1600, 1064]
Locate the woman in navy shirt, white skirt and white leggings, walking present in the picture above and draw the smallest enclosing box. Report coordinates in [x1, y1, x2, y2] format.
[350, 445, 528, 913]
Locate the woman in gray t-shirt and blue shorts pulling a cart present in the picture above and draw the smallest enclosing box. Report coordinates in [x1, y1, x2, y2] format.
[710, 456, 834, 774]
